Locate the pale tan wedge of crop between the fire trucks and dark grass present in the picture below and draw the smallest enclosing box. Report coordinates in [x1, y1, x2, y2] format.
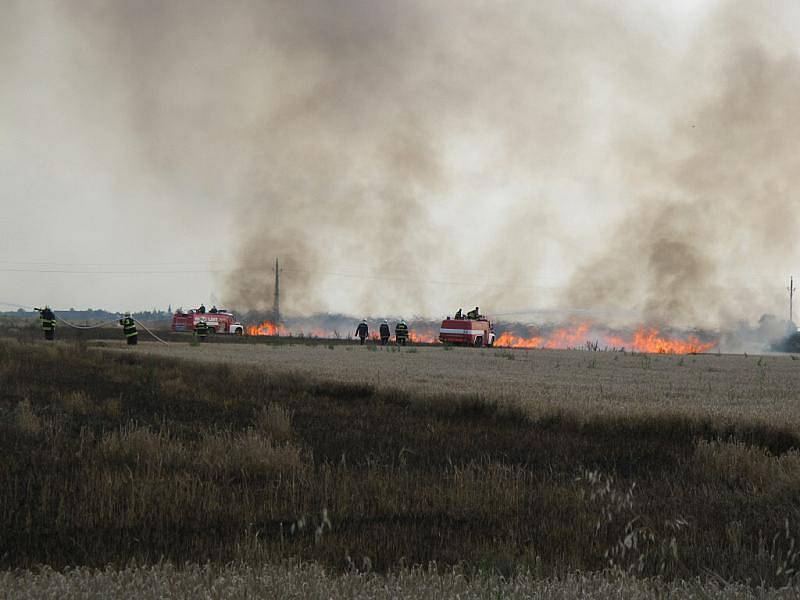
[104, 342, 800, 430]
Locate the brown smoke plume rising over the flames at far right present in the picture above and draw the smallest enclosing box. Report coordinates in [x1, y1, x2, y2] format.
[569, 27, 800, 325]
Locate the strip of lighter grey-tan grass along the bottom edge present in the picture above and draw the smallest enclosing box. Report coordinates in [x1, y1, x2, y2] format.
[0, 564, 797, 600]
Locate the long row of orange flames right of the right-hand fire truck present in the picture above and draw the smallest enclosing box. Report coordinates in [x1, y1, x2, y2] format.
[495, 323, 716, 354]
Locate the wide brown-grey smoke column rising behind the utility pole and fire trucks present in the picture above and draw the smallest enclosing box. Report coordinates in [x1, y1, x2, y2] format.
[223, 1, 644, 314]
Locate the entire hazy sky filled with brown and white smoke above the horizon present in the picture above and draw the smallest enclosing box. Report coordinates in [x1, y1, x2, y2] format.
[0, 0, 800, 325]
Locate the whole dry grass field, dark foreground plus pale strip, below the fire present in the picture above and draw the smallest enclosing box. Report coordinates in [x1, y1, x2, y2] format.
[0, 337, 800, 597]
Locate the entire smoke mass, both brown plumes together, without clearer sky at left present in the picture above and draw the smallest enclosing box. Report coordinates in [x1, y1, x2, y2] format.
[225, 2, 800, 325]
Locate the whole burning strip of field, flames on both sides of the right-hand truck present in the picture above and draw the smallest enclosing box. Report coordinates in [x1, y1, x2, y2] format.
[247, 317, 719, 354]
